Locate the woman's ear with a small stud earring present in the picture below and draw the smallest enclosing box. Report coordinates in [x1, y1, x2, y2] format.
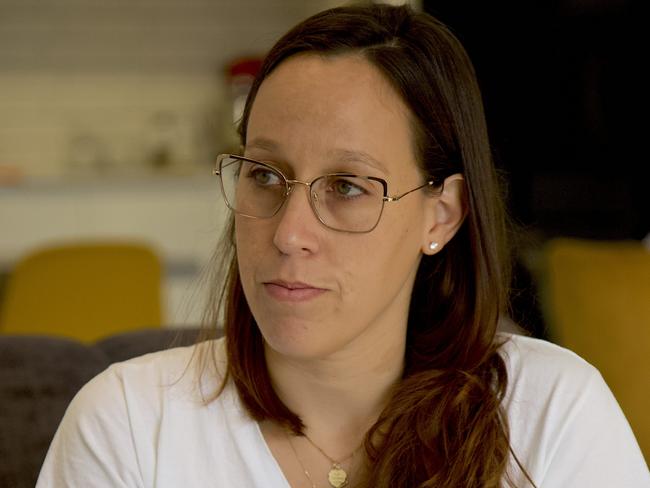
[422, 173, 467, 255]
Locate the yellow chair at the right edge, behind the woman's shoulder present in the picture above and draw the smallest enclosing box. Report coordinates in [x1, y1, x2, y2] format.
[541, 239, 650, 460]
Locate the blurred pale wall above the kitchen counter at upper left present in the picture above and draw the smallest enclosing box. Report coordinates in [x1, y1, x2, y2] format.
[0, 0, 340, 178]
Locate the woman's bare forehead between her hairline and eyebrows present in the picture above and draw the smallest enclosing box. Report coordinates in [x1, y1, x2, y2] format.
[246, 54, 414, 174]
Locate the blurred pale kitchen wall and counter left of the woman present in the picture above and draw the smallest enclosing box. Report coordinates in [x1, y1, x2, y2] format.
[0, 0, 356, 325]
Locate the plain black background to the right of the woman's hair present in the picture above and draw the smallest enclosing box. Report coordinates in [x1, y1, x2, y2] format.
[423, 0, 650, 340]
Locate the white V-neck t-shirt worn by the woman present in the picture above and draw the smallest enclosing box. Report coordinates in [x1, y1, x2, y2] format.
[36, 335, 650, 488]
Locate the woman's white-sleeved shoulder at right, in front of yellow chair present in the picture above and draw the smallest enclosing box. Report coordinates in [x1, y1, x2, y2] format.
[498, 334, 649, 487]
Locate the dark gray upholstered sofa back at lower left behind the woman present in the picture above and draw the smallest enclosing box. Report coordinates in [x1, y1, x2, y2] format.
[0, 328, 205, 488]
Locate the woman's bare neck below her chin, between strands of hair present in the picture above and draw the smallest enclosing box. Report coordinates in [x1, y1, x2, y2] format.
[266, 334, 405, 458]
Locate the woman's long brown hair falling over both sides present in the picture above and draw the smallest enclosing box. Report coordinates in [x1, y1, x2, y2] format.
[201, 5, 528, 488]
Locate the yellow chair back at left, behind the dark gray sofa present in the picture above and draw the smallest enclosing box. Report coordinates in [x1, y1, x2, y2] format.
[0, 243, 162, 342]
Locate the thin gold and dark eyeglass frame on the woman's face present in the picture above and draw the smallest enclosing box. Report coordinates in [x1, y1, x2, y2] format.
[212, 154, 435, 234]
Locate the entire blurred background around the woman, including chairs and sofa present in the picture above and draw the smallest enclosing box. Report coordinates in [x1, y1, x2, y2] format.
[0, 0, 650, 480]
